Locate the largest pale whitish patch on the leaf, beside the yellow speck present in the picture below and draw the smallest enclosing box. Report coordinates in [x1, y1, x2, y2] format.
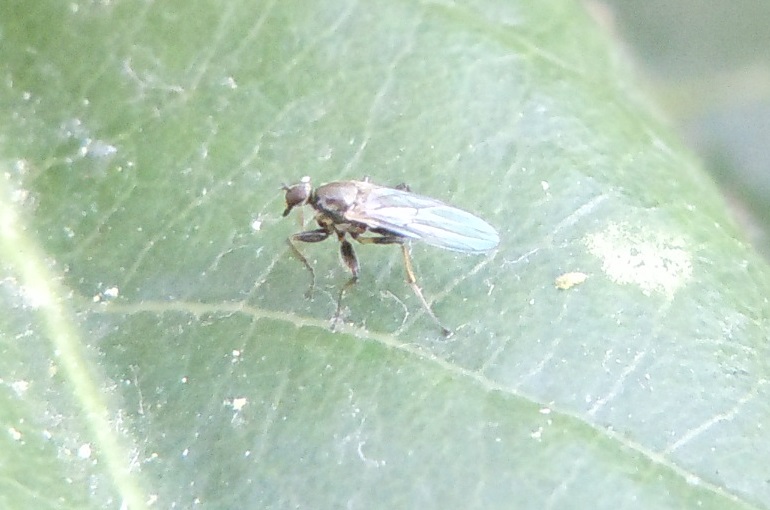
[584, 223, 692, 298]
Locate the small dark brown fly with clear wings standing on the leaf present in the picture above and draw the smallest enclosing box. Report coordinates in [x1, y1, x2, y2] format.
[283, 177, 500, 336]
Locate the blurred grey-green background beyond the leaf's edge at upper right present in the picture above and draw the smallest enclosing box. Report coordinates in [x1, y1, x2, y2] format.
[585, 0, 770, 258]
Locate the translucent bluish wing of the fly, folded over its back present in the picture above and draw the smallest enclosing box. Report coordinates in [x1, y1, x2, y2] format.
[345, 183, 500, 253]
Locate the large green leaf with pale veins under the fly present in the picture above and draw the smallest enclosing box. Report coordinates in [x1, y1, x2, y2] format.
[0, 0, 770, 509]
